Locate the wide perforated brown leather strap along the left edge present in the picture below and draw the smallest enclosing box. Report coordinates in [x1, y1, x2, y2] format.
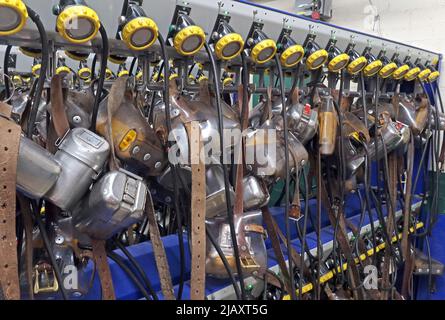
[0, 115, 21, 300]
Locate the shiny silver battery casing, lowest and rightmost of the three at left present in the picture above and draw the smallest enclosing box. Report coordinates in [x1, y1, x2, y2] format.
[73, 169, 147, 240]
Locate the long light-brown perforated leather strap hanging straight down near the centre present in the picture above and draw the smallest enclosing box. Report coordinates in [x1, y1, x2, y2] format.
[185, 121, 206, 300]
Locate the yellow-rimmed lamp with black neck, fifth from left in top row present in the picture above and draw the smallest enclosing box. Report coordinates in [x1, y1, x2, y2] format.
[210, 14, 244, 60]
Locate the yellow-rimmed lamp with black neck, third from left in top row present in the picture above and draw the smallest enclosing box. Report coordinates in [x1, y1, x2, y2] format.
[121, 2, 158, 51]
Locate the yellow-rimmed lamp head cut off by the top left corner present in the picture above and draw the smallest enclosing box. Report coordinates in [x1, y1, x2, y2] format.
[0, 0, 28, 36]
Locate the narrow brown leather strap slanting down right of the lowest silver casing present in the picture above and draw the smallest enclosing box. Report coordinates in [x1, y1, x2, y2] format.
[145, 192, 175, 300]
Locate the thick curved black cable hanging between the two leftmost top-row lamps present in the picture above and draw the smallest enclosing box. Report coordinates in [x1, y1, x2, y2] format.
[26, 6, 49, 138]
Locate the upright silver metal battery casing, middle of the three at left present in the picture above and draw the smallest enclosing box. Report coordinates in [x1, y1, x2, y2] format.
[46, 128, 110, 210]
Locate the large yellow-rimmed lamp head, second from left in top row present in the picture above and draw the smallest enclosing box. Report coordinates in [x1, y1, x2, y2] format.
[53, 0, 100, 43]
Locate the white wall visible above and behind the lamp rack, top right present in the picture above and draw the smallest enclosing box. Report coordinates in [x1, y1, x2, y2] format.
[252, 0, 445, 92]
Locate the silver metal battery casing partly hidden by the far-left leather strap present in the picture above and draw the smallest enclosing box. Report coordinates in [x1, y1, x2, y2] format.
[17, 136, 62, 198]
